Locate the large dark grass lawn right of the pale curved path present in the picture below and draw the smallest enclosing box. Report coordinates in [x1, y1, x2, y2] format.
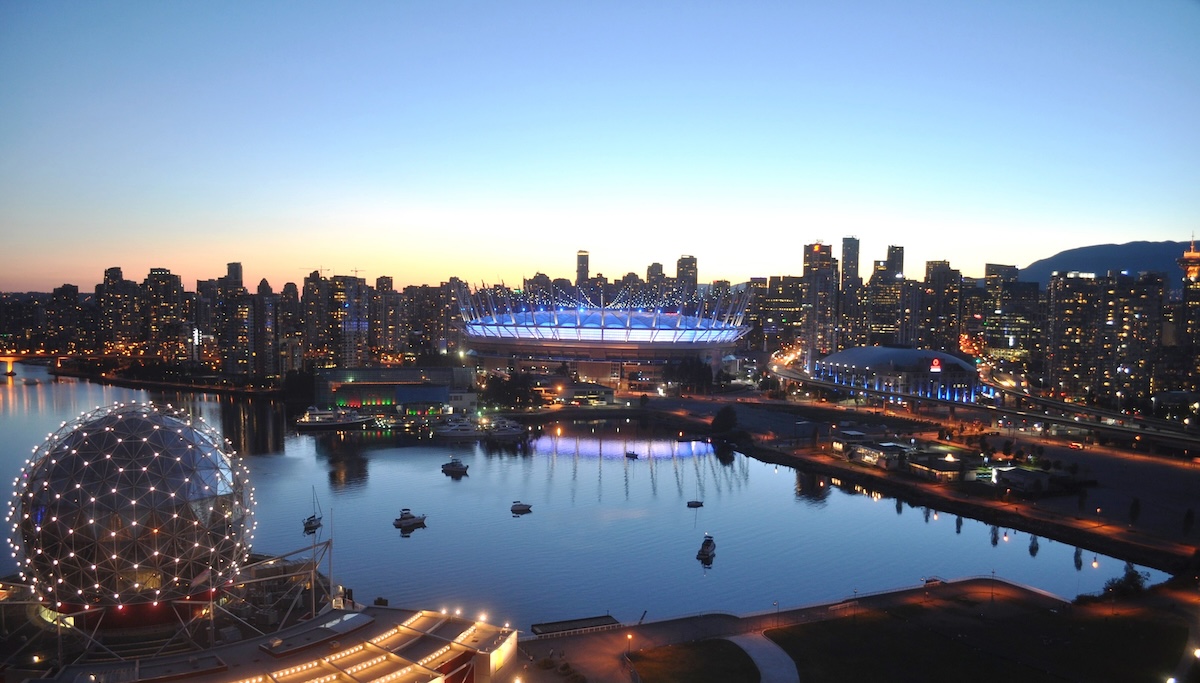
[767, 600, 1188, 683]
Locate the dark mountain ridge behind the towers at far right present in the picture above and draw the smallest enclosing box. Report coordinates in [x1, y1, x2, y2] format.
[1020, 241, 1188, 289]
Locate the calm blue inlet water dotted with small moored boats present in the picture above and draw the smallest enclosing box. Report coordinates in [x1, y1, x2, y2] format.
[0, 366, 1165, 629]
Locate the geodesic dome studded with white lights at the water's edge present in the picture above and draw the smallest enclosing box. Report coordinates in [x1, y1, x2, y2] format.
[8, 403, 253, 607]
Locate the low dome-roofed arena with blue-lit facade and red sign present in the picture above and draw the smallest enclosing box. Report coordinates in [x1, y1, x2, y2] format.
[810, 346, 990, 403]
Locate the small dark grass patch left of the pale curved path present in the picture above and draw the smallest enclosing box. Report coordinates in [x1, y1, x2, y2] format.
[630, 639, 758, 683]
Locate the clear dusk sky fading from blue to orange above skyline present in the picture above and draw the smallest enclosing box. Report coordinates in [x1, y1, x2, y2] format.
[0, 0, 1200, 292]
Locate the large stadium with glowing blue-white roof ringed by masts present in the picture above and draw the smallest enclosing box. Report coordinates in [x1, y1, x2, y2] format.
[458, 282, 750, 390]
